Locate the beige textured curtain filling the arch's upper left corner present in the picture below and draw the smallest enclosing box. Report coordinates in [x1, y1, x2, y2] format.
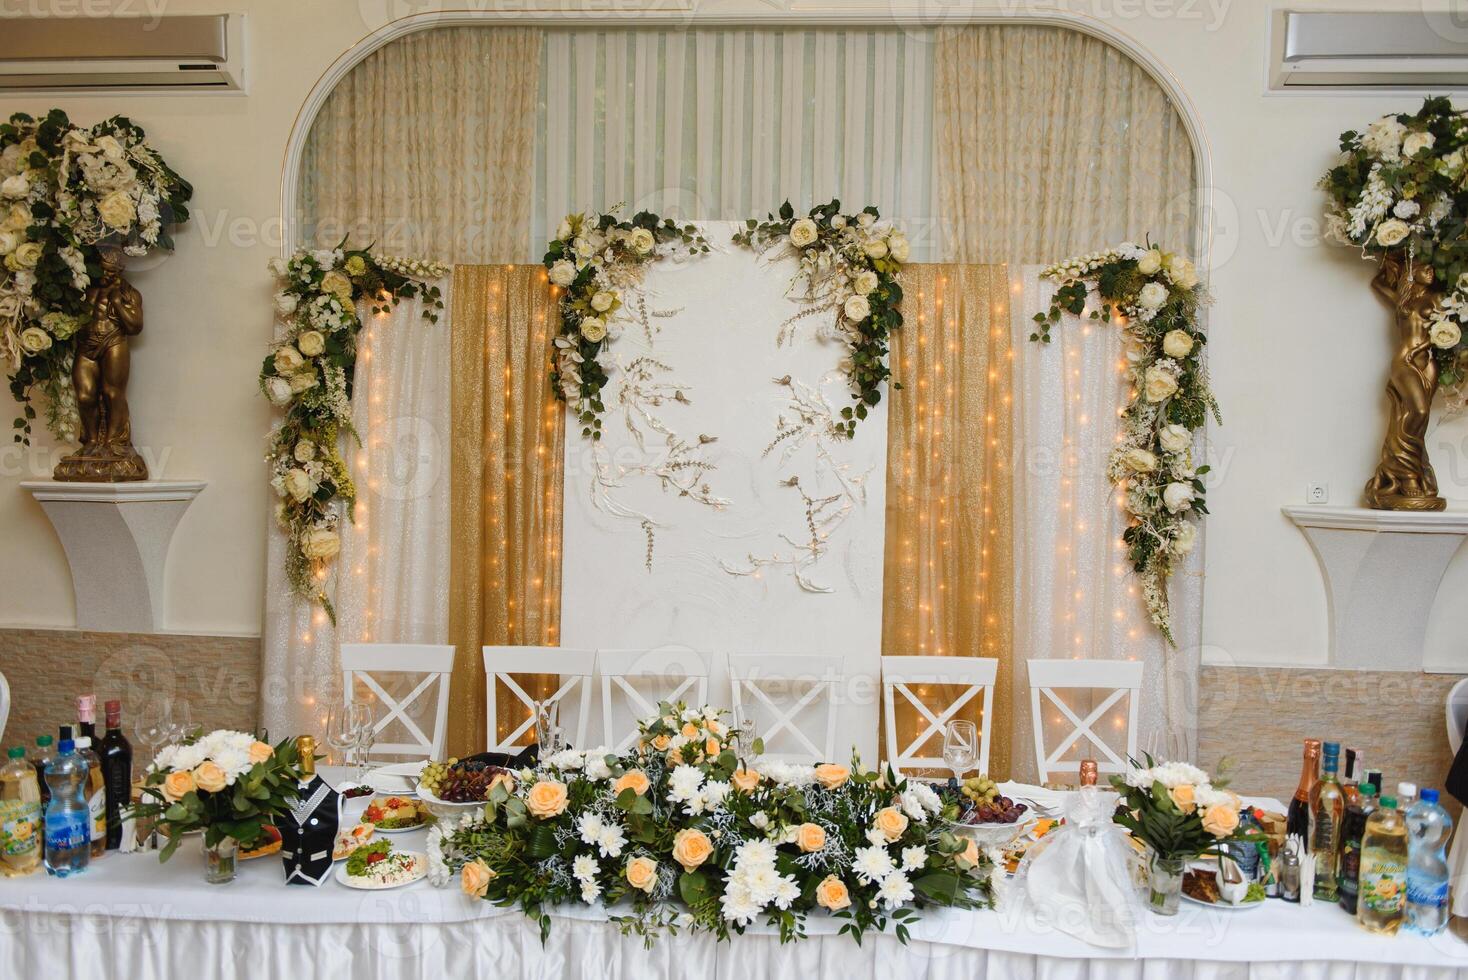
[298, 26, 545, 263]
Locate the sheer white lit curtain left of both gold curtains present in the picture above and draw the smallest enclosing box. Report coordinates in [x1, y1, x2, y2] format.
[261, 289, 454, 738]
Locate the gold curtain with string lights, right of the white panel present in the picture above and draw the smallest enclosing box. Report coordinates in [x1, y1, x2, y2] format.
[882, 264, 1013, 778]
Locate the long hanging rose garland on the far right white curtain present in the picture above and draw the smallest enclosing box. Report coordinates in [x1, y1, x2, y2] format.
[1029, 242, 1223, 646]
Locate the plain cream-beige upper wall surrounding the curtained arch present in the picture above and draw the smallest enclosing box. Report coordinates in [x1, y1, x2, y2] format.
[0, 0, 1468, 666]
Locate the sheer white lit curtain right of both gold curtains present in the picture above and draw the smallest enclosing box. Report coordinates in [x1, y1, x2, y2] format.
[1011, 266, 1202, 778]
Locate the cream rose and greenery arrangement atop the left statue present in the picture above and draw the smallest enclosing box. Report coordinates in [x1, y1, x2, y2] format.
[0, 109, 194, 443]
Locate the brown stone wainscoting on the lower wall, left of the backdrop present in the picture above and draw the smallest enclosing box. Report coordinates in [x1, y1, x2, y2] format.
[0, 629, 260, 747]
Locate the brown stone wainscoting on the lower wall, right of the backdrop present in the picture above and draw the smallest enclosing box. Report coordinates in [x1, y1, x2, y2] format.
[1198, 666, 1462, 817]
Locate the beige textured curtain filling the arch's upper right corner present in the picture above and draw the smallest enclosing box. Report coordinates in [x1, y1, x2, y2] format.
[932, 23, 1196, 264]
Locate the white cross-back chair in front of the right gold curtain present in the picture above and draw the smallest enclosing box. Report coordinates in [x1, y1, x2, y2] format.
[882, 657, 1000, 773]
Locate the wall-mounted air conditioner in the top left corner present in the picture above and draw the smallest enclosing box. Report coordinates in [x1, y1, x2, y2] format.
[0, 13, 245, 91]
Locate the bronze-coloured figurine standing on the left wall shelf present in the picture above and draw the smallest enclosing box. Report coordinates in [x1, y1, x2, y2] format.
[53, 248, 148, 483]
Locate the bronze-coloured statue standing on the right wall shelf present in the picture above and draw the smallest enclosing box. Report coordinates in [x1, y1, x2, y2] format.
[1367, 252, 1447, 511]
